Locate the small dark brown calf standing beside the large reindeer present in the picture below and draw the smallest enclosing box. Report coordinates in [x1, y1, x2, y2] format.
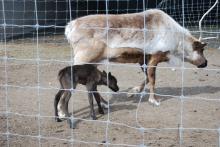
[54, 64, 119, 127]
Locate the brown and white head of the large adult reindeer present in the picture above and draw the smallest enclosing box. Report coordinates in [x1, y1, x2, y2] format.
[185, 41, 208, 68]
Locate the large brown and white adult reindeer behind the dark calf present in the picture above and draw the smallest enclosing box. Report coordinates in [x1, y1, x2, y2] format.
[65, 9, 207, 105]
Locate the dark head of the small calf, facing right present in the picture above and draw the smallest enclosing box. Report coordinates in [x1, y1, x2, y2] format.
[102, 70, 119, 92]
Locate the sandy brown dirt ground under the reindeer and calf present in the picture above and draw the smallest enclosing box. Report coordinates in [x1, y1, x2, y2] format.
[0, 35, 220, 147]
